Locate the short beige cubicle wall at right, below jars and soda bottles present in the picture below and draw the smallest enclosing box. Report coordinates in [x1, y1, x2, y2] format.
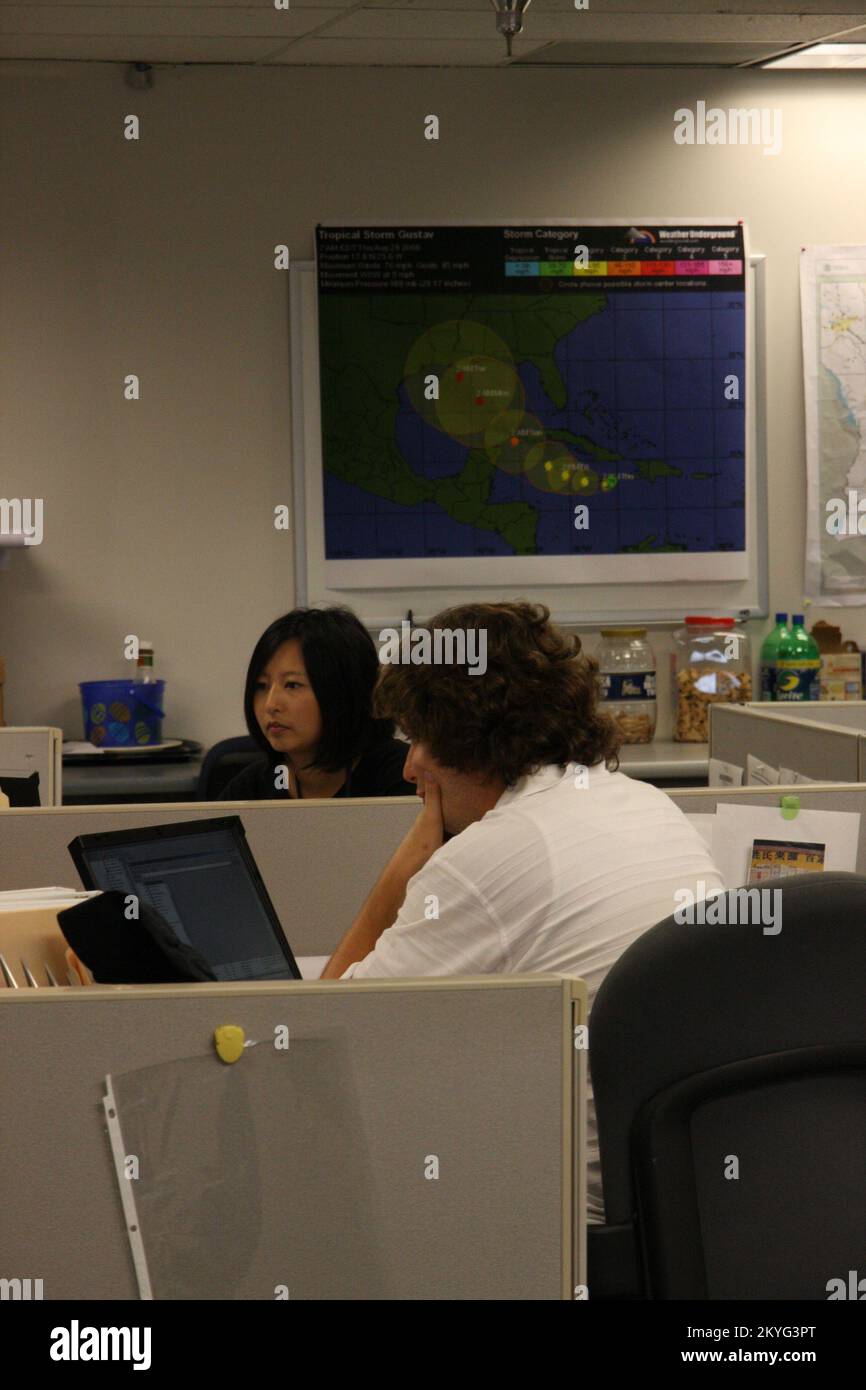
[709, 705, 866, 783]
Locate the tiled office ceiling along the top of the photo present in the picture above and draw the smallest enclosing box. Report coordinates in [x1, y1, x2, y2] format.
[0, 0, 866, 69]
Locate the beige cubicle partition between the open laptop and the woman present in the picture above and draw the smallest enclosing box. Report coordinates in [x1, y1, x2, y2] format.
[0, 796, 420, 956]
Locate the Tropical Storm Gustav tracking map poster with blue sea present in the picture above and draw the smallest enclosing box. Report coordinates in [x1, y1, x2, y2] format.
[317, 228, 745, 562]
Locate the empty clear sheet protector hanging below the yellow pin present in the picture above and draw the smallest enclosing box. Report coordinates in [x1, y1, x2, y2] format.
[107, 1030, 395, 1301]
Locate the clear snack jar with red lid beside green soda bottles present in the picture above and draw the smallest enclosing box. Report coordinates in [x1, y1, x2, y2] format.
[671, 617, 752, 744]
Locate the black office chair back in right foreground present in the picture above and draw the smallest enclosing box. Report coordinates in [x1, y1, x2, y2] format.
[588, 873, 866, 1300]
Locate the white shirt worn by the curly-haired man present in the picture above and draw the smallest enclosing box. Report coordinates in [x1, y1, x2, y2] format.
[342, 763, 723, 1222]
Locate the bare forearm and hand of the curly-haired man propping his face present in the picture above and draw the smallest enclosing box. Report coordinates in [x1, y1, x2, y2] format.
[320, 777, 445, 980]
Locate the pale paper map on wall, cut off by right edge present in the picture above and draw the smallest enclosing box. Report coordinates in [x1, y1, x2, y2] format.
[799, 246, 866, 605]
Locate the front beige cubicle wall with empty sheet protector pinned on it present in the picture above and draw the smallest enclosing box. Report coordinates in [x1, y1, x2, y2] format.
[0, 976, 587, 1300]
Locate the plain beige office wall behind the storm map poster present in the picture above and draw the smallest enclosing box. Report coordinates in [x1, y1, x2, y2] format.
[0, 63, 866, 742]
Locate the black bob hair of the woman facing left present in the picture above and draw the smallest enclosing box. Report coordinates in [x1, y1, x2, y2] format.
[243, 607, 393, 773]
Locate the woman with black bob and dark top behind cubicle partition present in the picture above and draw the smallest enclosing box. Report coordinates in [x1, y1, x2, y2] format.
[220, 607, 414, 801]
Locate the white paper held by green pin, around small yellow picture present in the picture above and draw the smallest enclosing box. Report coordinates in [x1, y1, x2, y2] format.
[710, 802, 860, 888]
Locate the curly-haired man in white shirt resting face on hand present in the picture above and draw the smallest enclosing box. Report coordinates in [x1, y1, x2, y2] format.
[322, 603, 723, 1222]
